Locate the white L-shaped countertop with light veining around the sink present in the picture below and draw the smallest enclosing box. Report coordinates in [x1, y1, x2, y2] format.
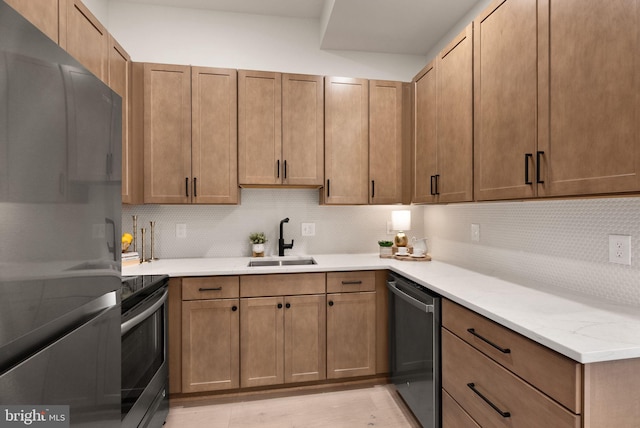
[122, 254, 640, 363]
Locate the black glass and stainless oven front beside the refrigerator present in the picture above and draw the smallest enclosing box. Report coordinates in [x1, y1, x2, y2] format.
[121, 287, 169, 428]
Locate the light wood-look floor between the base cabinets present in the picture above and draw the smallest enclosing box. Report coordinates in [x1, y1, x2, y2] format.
[165, 385, 420, 428]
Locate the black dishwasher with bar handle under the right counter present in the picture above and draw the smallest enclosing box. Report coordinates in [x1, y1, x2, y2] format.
[387, 274, 441, 428]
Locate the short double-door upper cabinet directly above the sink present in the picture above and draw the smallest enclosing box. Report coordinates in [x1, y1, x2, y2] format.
[238, 70, 324, 187]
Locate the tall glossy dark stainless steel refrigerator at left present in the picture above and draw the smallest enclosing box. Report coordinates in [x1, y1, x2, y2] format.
[0, 0, 122, 427]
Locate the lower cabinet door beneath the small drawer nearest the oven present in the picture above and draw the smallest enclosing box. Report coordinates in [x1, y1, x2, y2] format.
[182, 299, 240, 393]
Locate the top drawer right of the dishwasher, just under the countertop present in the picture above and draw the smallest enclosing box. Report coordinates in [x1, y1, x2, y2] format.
[442, 299, 582, 413]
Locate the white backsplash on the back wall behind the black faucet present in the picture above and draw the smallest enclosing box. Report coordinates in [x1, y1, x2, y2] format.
[122, 189, 424, 258]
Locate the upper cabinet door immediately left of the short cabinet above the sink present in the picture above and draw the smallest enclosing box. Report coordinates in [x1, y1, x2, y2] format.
[191, 67, 238, 204]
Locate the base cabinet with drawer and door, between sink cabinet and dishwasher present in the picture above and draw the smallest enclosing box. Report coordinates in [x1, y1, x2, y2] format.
[327, 271, 377, 379]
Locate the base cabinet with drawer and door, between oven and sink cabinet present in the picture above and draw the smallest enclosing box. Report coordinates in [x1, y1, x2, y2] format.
[181, 276, 240, 393]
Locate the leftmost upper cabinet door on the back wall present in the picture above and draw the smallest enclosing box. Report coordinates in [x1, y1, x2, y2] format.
[144, 64, 193, 204]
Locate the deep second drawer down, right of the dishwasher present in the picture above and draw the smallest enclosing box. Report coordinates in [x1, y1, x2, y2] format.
[442, 329, 581, 428]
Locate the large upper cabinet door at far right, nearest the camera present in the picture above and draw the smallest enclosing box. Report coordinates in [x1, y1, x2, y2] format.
[538, 0, 640, 196]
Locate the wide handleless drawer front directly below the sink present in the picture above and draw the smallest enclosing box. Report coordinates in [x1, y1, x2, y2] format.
[240, 273, 326, 297]
